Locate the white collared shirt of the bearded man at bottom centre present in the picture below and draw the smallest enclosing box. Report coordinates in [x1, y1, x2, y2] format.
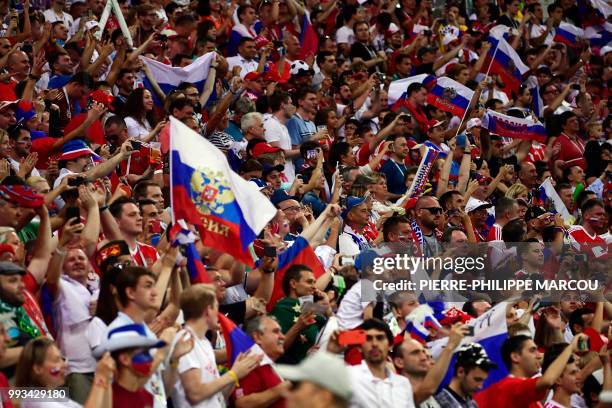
[348, 361, 415, 408]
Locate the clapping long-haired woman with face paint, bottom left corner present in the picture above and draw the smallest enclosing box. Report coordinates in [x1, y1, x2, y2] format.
[15, 337, 115, 408]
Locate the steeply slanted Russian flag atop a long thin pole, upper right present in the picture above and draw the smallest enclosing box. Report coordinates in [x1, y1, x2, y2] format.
[481, 36, 529, 97]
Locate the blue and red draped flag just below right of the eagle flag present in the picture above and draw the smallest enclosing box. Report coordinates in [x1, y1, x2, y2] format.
[266, 236, 325, 312]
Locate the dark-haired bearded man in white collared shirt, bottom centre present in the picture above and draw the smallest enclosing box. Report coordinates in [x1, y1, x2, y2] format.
[349, 319, 415, 408]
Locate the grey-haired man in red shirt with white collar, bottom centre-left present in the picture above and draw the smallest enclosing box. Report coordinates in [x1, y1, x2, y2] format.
[233, 316, 289, 408]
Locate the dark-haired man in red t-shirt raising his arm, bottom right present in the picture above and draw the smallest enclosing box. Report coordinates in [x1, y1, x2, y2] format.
[474, 334, 586, 408]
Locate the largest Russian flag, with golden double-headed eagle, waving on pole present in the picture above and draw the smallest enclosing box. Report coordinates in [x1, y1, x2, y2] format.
[170, 116, 276, 265]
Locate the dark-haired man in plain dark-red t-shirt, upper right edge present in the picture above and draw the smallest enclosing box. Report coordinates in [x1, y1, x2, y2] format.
[552, 112, 586, 177]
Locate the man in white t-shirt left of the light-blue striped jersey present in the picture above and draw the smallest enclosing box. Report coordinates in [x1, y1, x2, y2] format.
[264, 91, 300, 183]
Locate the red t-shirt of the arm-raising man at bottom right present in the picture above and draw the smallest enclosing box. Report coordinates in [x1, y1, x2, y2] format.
[474, 377, 547, 408]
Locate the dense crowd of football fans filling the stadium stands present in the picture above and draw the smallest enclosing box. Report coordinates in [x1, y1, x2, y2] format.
[0, 0, 612, 408]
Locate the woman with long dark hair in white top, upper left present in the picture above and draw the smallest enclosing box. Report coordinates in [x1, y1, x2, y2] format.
[122, 88, 157, 139]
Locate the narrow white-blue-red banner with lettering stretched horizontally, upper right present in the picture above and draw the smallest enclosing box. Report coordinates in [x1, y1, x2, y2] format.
[482, 109, 546, 143]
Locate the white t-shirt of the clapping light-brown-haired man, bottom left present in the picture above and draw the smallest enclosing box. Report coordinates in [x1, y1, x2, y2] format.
[172, 328, 225, 408]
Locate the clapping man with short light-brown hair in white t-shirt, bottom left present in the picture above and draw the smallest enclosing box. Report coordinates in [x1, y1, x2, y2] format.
[172, 284, 262, 408]
